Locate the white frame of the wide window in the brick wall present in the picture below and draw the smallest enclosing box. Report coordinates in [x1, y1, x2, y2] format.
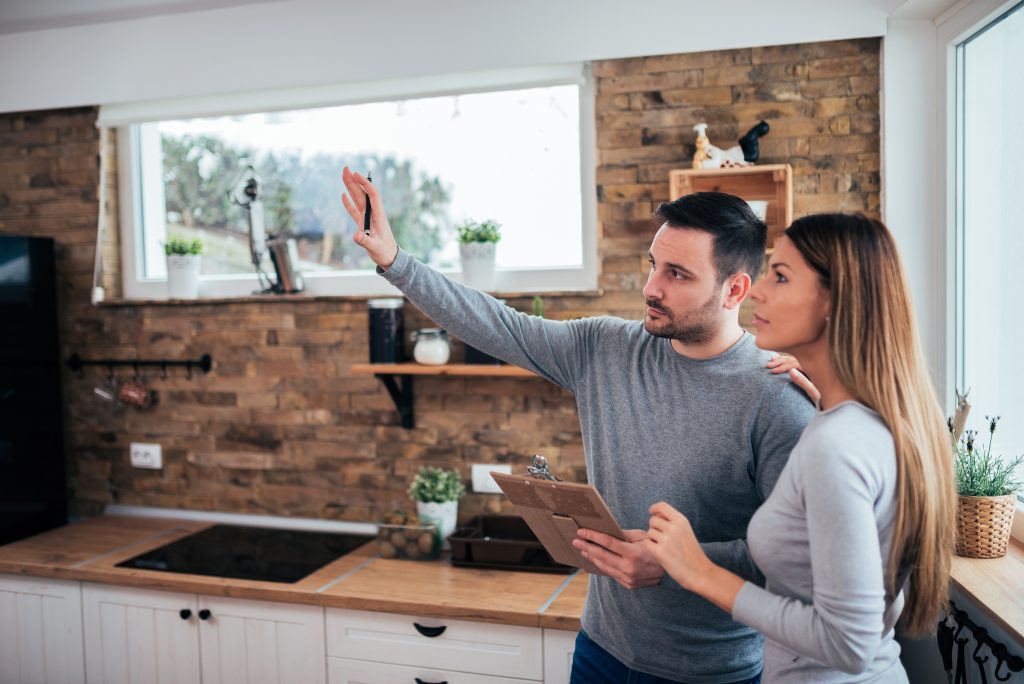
[107, 63, 598, 300]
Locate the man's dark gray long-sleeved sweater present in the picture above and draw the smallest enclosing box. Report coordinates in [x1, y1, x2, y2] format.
[384, 251, 814, 684]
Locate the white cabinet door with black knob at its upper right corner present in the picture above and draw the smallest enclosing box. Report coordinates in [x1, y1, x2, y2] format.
[82, 584, 200, 684]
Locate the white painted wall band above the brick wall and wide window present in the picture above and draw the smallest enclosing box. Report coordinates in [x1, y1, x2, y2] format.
[0, 0, 888, 112]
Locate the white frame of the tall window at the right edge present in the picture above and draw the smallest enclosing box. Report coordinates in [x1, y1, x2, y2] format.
[935, 0, 1024, 528]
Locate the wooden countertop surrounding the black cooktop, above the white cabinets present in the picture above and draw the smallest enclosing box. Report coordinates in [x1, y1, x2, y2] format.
[0, 515, 587, 630]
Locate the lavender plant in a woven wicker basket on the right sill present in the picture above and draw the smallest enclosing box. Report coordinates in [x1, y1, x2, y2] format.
[948, 400, 1024, 558]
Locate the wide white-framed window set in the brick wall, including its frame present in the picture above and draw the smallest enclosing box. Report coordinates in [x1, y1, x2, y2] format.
[100, 65, 597, 299]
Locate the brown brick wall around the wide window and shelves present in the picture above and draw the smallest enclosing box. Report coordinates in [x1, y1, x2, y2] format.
[0, 40, 880, 520]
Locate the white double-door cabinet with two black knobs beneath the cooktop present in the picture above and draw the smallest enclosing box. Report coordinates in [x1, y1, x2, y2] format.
[83, 585, 327, 684]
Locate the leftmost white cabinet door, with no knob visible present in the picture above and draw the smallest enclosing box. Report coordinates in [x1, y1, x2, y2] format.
[0, 574, 85, 684]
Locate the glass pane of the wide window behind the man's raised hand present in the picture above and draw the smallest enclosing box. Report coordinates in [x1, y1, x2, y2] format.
[151, 85, 583, 273]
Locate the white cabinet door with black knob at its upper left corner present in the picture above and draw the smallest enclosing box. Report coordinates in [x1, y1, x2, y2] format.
[199, 596, 327, 684]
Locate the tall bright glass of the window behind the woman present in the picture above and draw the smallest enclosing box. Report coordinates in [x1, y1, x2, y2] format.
[955, 2, 1024, 491]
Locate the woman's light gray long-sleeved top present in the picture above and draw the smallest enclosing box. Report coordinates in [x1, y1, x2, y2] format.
[732, 401, 907, 684]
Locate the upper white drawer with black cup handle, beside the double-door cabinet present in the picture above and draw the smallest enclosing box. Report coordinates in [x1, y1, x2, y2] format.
[327, 608, 544, 681]
